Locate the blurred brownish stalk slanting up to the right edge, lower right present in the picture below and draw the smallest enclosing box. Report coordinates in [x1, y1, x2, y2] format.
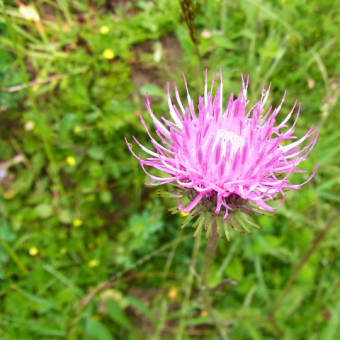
[269, 209, 340, 321]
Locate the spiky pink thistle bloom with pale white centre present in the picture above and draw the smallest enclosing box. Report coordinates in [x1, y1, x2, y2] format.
[127, 72, 319, 219]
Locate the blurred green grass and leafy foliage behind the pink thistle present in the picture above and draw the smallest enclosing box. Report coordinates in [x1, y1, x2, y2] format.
[0, 0, 340, 340]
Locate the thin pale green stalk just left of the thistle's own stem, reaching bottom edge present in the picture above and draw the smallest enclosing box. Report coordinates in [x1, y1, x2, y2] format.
[176, 229, 202, 340]
